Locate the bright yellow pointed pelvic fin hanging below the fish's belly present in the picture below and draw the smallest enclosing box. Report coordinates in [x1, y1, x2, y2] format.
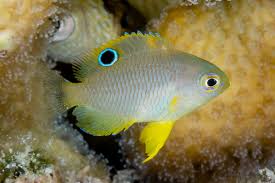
[139, 121, 174, 163]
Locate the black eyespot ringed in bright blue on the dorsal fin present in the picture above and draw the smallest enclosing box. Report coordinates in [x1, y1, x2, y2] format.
[98, 48, 118, 67]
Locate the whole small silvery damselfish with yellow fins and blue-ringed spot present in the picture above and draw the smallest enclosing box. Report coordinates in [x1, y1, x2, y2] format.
[52, 32, 230, 163]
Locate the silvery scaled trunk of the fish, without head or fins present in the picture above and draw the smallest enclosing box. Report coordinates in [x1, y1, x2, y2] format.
[64, 50, 225, 122]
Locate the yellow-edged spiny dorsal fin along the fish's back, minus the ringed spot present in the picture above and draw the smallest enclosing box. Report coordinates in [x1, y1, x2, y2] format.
[73, 32, 169, 81]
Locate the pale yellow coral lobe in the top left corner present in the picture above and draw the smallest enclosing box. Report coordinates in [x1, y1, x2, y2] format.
[0, 0, 56, 53]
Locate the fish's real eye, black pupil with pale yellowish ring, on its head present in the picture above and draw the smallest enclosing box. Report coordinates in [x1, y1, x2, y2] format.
[201, 73, 220, 92]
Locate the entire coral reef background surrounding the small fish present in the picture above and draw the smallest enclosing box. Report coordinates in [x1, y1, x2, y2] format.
[0, 0, 275, 183]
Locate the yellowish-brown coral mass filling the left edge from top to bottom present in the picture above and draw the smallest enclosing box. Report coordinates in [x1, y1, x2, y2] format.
[0, 0, 110, 182]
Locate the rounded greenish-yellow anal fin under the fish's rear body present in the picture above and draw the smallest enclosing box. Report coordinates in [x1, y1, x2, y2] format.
[73, 106, 136, 136]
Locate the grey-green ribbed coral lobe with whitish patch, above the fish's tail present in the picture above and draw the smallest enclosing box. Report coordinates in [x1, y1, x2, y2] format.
[48, 0, 119, 62]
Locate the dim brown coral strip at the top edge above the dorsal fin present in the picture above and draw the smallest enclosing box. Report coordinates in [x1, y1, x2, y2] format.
[128, 0, 230, 20]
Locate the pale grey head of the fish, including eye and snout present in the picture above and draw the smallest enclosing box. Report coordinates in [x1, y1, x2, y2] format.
[176, 53, 230, 113]
